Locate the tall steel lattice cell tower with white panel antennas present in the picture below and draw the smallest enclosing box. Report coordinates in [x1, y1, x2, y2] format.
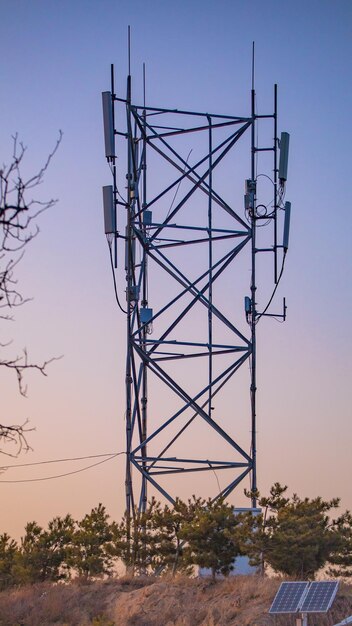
[102, 47, 291, 532]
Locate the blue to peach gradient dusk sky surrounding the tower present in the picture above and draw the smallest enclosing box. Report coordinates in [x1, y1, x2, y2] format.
[0, 0, 352, 537]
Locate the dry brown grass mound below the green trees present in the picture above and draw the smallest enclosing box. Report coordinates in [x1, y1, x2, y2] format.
[0, 576, 352, 626]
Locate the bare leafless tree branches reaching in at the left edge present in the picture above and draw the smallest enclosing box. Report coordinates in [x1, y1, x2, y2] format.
[0, 131, 62, 456]
